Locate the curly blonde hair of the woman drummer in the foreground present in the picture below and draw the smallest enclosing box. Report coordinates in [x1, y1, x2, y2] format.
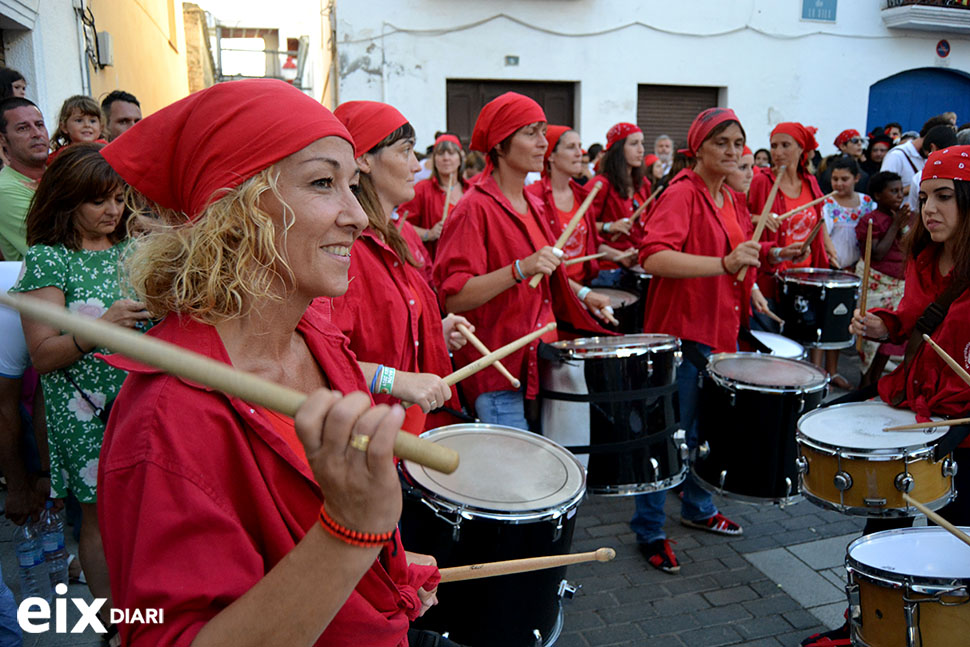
[125, 167, 294, 324]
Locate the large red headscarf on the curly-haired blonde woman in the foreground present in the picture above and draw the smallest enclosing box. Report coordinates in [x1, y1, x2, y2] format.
[101, 79, 354, 220]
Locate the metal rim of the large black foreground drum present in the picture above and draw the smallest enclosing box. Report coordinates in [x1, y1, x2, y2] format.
[398, 422, 586, 523]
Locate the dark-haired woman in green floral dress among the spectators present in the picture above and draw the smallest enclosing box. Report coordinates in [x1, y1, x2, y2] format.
[14, 144, 149, 624]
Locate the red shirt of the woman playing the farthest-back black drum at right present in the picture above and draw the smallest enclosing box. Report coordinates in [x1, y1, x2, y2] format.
[748, 168, 829, 299]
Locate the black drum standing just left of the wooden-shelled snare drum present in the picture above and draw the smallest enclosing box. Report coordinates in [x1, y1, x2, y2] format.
[692, 353, 829, 503]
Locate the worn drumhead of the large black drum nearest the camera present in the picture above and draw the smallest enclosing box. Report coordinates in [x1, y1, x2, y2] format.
[404, 424, 586, 513]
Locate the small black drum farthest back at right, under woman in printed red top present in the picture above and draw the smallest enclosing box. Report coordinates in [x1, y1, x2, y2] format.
[777, 267, 862, 349]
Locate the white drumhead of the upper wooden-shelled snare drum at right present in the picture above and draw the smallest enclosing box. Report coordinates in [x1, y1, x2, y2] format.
[798, 402, 948, 452]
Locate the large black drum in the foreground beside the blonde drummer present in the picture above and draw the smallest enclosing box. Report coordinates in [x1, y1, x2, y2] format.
[398, 424, 586, 647]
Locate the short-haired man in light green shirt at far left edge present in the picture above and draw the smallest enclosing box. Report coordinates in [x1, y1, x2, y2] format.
[0, 97, 48, 261]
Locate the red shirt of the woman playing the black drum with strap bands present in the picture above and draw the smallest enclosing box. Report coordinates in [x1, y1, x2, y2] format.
[434, 172, 610, 403]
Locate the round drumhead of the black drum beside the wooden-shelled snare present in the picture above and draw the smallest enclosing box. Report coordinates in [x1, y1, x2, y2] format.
[707, 353, 829, 390]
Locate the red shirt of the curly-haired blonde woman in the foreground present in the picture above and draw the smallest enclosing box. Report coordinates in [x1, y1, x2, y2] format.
[98, 306, 427, 647]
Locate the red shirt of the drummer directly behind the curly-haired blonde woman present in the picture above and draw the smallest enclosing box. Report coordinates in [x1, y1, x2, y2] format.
[330, 230, 460, 433]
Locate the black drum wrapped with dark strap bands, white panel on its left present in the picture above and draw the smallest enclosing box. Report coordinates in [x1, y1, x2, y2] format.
[539, 335, 687, 496]
